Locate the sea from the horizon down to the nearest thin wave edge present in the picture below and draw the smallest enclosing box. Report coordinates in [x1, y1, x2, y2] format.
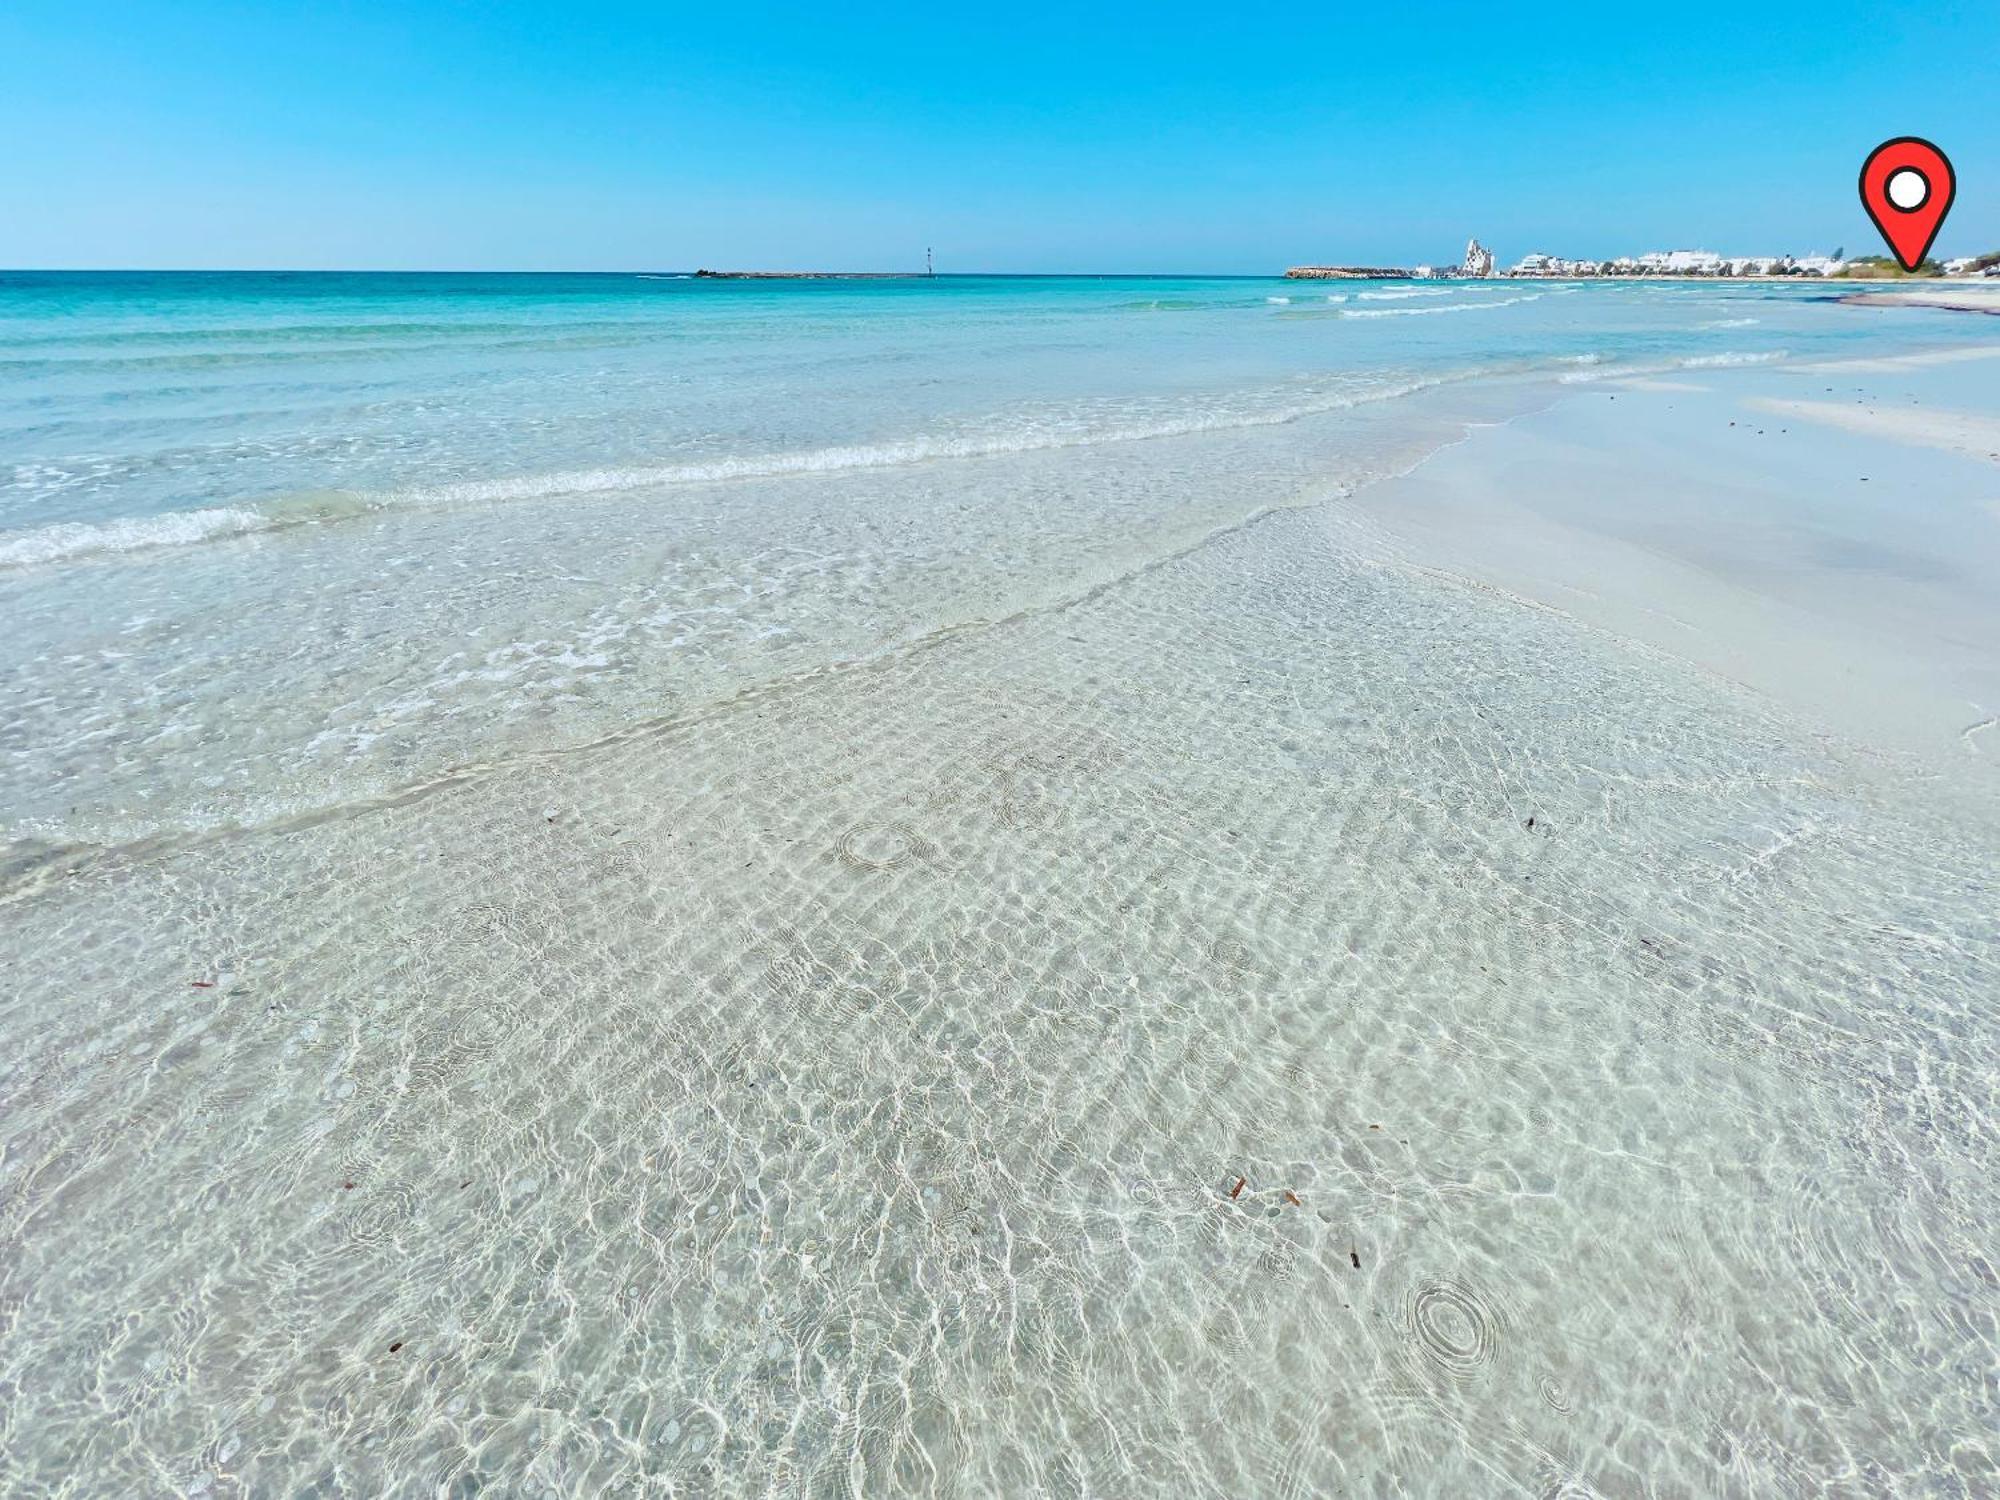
[0, 274, 1972, 844]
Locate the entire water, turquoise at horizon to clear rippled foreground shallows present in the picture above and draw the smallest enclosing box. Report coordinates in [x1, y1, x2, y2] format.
[0, 278, 2000, 1496]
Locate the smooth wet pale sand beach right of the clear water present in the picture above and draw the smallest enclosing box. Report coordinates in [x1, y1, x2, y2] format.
[1346, 346, 2000, 802]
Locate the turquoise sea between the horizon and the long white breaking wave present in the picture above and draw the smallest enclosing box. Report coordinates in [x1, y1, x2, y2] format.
[0, 272, 1952, 548]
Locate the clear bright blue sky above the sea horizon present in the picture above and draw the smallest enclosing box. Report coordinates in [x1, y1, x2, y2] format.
[0, 0, 2000, 272]
